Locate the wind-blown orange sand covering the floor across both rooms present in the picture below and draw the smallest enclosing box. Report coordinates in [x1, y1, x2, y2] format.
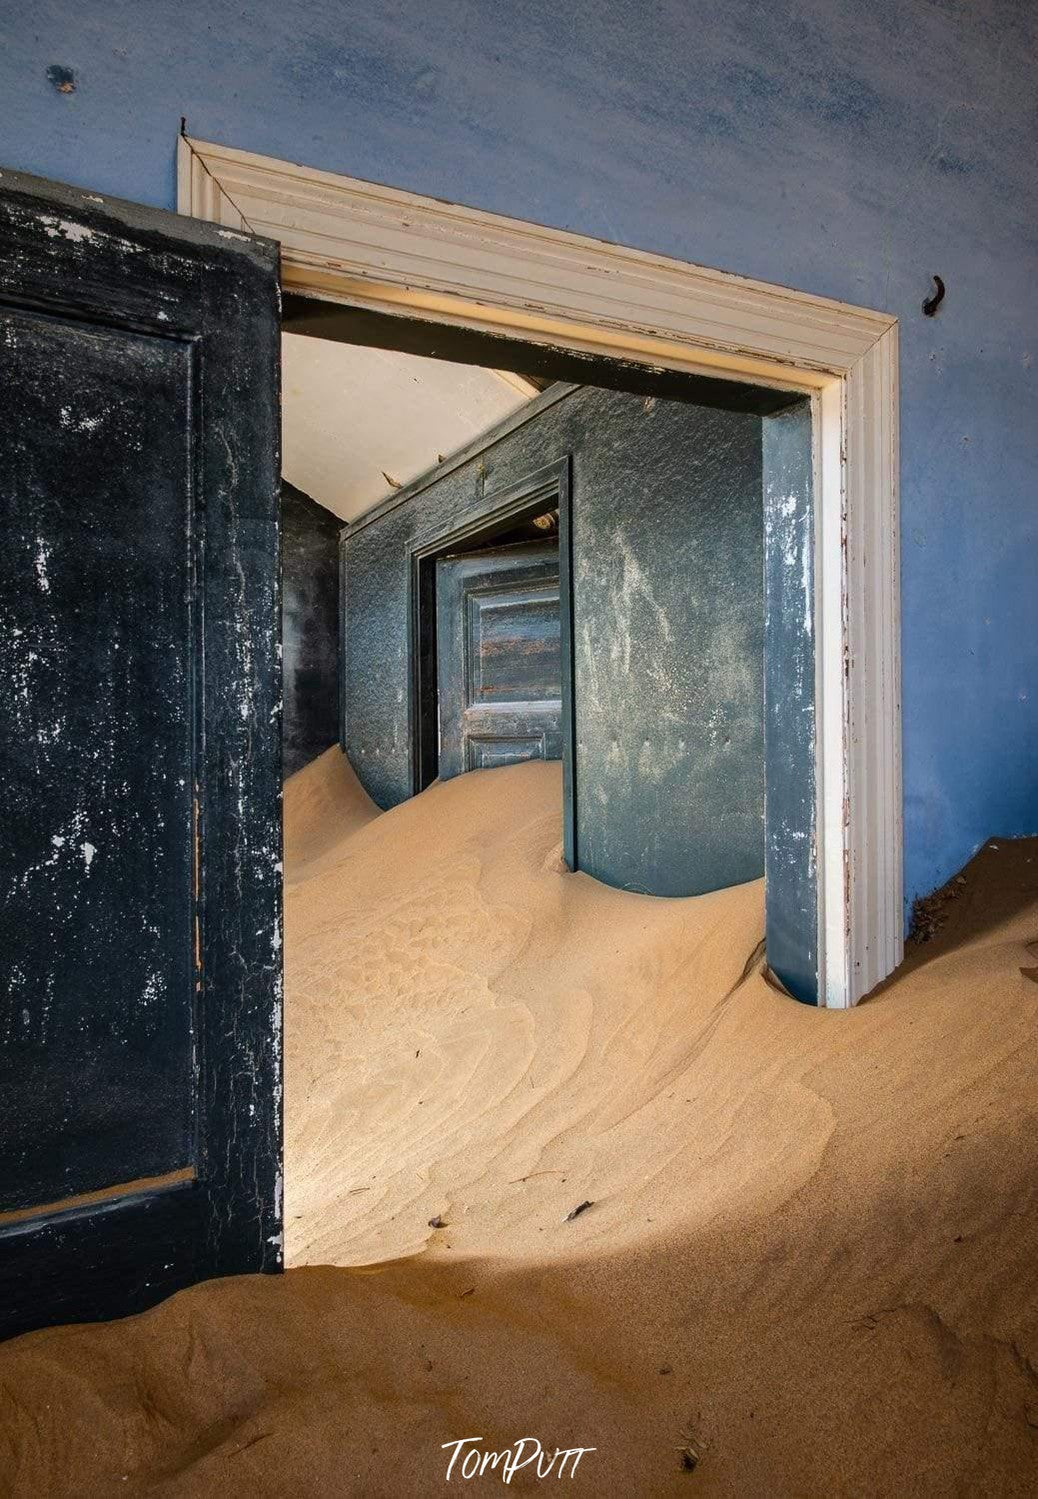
[0, 751, 1038, 1496]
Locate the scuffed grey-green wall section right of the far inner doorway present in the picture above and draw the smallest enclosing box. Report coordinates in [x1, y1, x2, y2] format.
[573, 399, 765, 896]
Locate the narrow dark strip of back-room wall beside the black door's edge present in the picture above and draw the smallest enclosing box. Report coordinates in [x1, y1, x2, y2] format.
[281, 483, 342, 776]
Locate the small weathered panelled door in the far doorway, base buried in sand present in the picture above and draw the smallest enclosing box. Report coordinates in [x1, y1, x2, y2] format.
[437, 541, 563, 781]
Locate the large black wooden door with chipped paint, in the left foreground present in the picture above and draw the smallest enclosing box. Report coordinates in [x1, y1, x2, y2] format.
[0, 171, 281, 1334]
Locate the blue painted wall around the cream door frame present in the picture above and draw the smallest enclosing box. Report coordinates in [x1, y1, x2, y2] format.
[0, 0, 1038, 899]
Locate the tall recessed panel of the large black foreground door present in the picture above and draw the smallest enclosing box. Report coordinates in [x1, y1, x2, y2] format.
[0, 309, 195, 1211]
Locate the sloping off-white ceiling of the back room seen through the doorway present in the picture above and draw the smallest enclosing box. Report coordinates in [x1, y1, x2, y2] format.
[282, 333, 537, 520]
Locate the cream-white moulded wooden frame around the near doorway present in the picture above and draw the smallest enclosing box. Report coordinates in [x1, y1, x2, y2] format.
[179, 136, 905, 1007]
